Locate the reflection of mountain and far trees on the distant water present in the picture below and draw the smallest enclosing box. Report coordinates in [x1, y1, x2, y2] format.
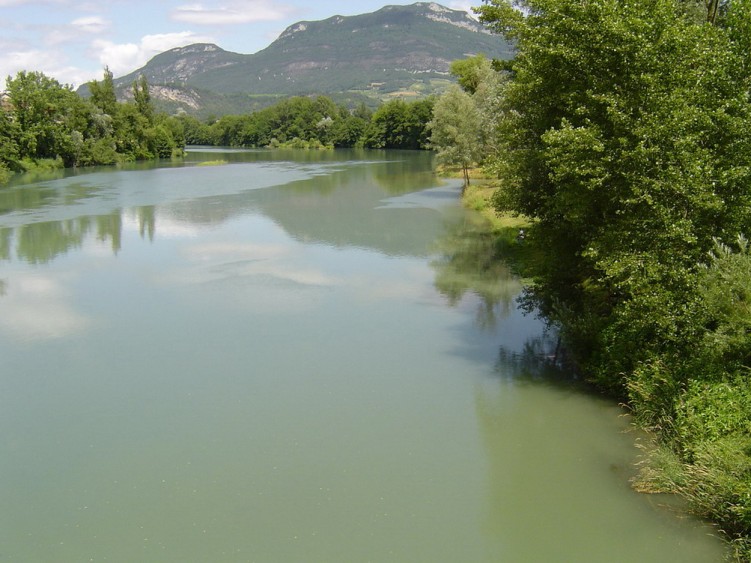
[0, 150, 439, 264]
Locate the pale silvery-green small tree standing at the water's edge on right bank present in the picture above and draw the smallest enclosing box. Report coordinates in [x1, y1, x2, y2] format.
[428, 85, 482, 186]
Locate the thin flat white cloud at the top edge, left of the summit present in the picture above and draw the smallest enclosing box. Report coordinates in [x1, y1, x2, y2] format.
[172, 0, 292, 25]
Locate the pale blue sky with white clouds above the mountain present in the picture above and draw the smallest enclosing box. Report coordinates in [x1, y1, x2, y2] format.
[0, 0, 482, 89]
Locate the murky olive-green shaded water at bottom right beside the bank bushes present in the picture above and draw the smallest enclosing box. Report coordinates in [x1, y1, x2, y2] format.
[475, 337, 722, 563]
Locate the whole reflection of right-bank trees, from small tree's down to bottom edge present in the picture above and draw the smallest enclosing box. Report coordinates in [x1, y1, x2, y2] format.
[431, 207, 722, 563]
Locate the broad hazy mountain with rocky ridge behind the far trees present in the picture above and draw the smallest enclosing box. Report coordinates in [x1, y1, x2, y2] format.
[92, 2, 513, 115]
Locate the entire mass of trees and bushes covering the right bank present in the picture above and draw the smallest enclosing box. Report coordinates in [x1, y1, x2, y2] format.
[478, 0, 751, 543]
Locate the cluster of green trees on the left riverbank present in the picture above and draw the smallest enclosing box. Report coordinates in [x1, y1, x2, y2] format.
[0, 69, 185, 182]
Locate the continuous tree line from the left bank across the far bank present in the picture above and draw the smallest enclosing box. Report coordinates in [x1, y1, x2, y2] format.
[0, 69, 434, 181]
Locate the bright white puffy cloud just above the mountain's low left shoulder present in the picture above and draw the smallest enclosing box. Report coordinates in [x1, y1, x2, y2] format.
[92, 31, 215, 76]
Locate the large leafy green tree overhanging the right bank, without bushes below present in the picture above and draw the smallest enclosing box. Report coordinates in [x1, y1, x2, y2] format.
[479, 0, 751, 388]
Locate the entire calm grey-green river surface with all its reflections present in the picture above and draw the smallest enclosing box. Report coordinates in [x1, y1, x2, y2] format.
[0, 149, 724, 563]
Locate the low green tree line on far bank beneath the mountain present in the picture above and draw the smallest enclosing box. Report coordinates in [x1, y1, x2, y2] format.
[178, 96, 433, 149]
